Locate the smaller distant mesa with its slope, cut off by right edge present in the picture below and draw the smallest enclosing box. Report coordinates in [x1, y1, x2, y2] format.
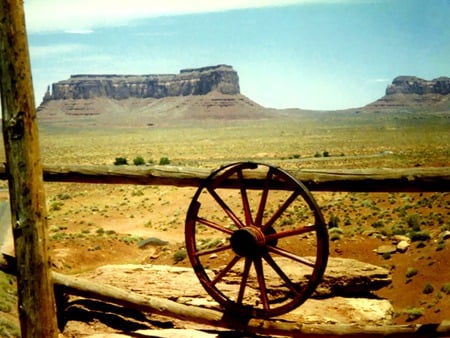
[363, 76, 450, 112]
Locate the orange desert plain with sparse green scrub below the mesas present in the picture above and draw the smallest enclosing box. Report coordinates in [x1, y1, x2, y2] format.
[0, 113, 450, 336]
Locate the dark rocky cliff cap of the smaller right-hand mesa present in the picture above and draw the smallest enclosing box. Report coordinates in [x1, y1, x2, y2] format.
[386, 76, 450, 95]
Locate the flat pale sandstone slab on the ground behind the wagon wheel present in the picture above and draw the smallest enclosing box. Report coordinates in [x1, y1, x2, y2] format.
[77, 258, 394, 325]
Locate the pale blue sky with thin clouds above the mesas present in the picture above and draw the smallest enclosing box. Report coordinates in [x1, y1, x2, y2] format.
[25, 0, 450, 110]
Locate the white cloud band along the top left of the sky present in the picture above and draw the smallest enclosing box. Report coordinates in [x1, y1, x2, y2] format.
[25, 0, 342, 33]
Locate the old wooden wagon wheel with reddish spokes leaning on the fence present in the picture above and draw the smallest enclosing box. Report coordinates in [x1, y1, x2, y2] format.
[185, 162, 328, 318]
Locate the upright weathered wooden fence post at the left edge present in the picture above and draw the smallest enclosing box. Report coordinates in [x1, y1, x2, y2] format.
[0, 0, 58, 338]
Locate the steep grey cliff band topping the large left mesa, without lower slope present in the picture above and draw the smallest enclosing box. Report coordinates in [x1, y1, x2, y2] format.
[43, 65, 240, 103]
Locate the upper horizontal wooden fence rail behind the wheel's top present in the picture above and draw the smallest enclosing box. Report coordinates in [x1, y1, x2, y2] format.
[0, 165, 450, 192]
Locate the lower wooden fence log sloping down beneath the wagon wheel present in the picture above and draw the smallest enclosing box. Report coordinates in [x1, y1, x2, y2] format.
[52, 272, 450, 338]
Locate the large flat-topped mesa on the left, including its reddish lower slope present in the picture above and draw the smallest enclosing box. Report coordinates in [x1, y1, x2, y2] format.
[38, 65, 280, 126]
